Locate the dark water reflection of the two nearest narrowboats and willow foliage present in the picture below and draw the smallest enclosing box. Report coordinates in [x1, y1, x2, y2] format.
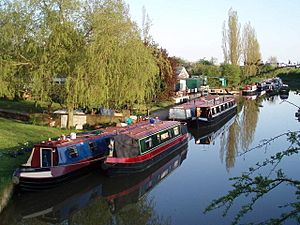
[1, 145, 188, 225]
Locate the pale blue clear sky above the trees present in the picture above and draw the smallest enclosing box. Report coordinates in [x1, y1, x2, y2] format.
[124, 0, 300, 63]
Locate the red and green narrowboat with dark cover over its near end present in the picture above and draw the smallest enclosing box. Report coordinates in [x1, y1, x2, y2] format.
[102, 120, 188, 176]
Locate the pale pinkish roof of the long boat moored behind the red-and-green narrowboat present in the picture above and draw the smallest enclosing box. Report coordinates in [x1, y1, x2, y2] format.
[173, 95, 235, 109]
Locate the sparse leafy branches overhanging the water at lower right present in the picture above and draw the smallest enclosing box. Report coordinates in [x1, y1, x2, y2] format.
[205, 131, 300, 224]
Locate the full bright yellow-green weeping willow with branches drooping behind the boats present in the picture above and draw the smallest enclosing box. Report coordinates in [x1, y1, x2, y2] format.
[83, 0, 158, 109]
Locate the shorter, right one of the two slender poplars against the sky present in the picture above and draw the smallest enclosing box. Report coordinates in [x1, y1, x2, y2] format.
[243, 23, 261, 77]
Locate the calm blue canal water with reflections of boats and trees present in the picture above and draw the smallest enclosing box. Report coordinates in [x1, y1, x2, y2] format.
[0, 92, 300, 225]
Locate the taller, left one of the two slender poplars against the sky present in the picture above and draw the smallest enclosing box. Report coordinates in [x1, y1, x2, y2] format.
[222, 8, 242, 65]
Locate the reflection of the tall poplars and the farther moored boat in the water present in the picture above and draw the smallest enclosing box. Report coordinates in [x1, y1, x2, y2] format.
[189, 96, 275, 170]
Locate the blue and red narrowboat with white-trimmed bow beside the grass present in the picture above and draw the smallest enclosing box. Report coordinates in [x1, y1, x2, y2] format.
[13, 130, 115, 190]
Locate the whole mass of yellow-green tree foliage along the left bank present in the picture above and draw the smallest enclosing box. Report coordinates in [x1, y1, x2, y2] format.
[0, 0, 168, 126]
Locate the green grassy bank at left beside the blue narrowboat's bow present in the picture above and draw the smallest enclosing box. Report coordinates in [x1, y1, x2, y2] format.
[0, 118, 66, 212]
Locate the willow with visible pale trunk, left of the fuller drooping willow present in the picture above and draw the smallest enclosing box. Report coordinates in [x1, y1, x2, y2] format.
[26, 0, 84, 126]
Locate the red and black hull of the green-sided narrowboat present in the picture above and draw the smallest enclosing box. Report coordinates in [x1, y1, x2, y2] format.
[102, 133, 188, 176]
